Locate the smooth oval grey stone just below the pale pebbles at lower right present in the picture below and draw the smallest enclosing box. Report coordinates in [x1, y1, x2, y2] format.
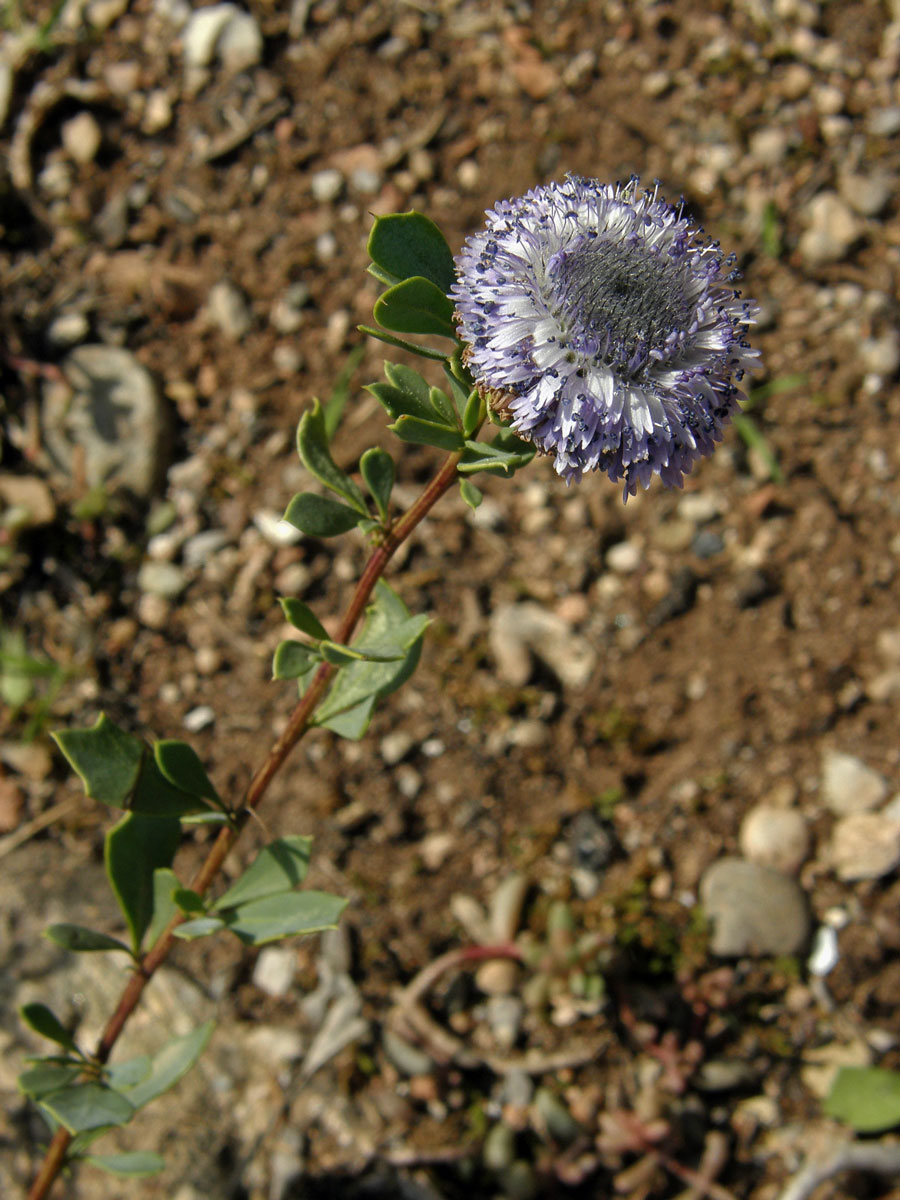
[700, 858, 810, 958]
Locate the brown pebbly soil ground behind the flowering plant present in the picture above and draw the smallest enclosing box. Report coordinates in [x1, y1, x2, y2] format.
[0, 0, 900, 1200]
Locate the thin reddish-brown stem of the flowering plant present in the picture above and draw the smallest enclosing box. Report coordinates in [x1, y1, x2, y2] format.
[28, 454, 461, 1200]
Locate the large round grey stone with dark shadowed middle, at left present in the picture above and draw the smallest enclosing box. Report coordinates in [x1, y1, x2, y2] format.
[42, 344, 170, 497]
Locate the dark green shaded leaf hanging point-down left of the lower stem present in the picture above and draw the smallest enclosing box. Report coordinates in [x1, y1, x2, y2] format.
[103, 812, 181, 954]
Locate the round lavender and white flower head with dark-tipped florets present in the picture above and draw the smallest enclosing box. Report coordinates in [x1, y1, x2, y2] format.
[451, 176, 758, 499]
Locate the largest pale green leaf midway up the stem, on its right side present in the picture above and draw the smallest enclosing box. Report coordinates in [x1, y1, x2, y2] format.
[313, 580, 428, 738]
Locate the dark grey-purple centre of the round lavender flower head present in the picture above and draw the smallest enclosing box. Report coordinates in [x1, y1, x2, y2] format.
[554, 241, 691, 366]
